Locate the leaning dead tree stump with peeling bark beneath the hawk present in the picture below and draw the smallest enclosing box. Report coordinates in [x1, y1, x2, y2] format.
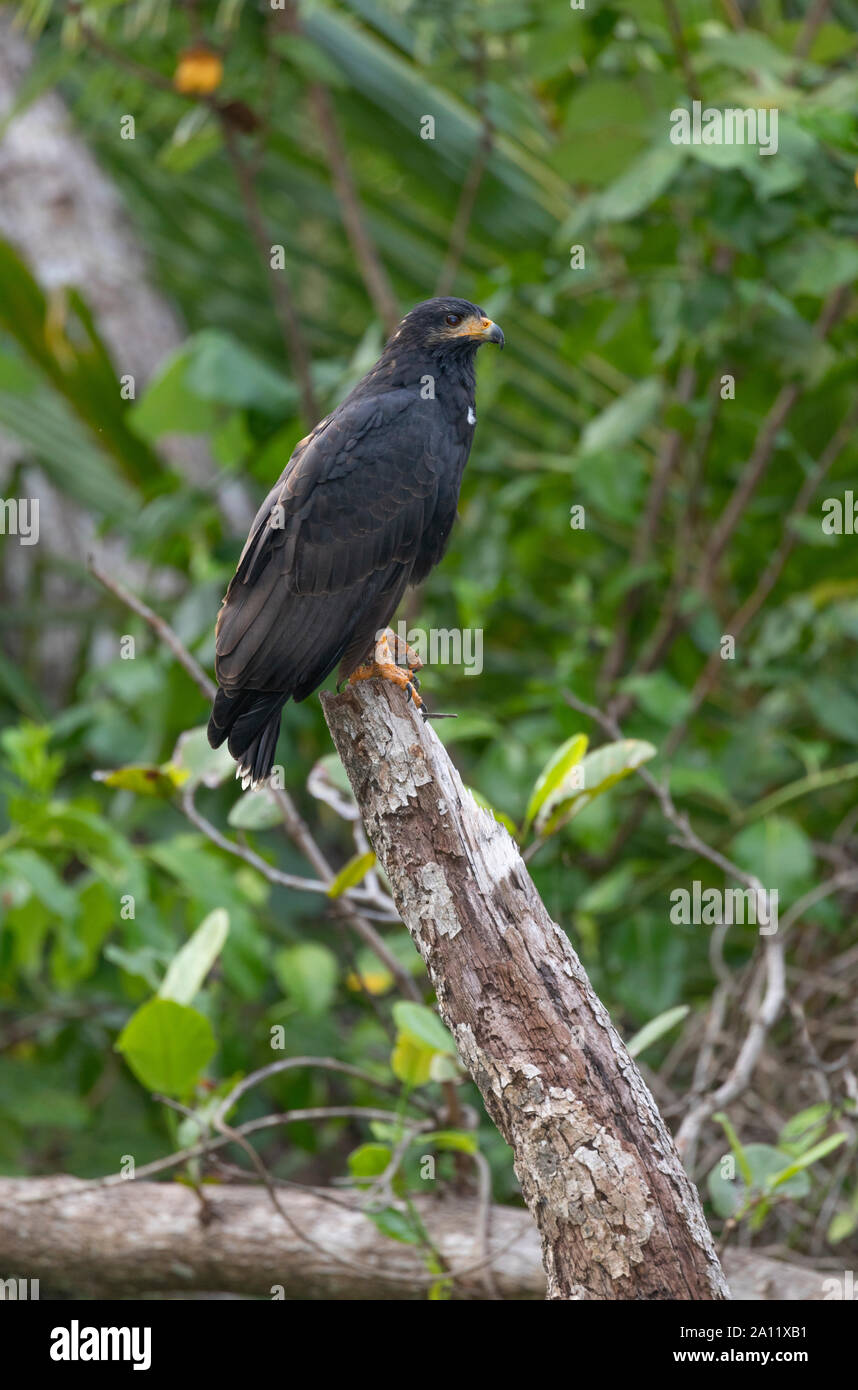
[321, 681, 729, 1300]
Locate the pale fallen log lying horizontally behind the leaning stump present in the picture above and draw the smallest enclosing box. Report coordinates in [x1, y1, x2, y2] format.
[0, 1177, 825, 1301]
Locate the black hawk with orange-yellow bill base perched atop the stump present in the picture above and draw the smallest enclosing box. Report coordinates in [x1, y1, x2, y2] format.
[209, 299, 503, 785]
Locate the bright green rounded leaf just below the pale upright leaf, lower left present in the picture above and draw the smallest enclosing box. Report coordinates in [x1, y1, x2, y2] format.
[115, 999, 217, 1098]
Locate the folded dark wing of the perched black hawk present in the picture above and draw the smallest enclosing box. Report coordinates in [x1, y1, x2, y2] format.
[216, 391, 442, 699]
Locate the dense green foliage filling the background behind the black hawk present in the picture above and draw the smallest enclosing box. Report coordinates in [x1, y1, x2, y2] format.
[0, 0, 858, 1273]
